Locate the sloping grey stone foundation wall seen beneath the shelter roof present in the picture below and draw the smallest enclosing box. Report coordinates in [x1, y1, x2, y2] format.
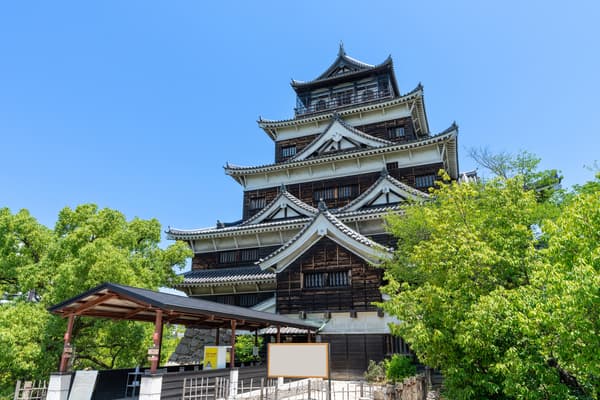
[168, 328, 231, 365]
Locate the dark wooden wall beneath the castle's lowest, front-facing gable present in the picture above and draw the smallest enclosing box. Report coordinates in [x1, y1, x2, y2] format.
[276, 238, 383, 314]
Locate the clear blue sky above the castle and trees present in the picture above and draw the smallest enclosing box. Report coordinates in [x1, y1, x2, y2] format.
[0, 0, 600, 233]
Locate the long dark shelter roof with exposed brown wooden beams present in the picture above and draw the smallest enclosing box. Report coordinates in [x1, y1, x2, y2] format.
[48, 283, 318, 331]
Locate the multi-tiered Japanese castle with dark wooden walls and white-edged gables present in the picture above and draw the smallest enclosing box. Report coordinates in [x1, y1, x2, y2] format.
[167, 45, 459, 372]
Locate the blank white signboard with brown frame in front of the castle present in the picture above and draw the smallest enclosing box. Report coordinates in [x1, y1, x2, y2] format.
[267, 343, 329, 378]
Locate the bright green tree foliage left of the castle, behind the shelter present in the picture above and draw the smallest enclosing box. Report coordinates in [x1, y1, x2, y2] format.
[0, 204, 190, 396]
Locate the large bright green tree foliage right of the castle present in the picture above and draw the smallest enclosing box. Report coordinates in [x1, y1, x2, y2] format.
[382, 175, 600, 399]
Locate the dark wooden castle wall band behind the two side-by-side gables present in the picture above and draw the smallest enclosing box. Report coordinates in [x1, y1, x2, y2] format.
[243, 163, 443, 219]
